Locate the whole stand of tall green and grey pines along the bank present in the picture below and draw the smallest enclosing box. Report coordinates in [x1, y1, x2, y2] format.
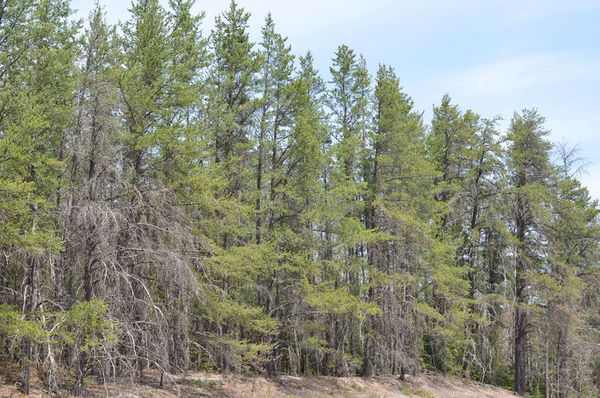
[0, 0, 600, 398]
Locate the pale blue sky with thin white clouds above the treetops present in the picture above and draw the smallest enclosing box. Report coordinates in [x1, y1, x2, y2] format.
[72, 0, 600, 199]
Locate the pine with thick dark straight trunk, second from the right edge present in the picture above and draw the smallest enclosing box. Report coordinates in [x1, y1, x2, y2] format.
[508, 110, 552, 394]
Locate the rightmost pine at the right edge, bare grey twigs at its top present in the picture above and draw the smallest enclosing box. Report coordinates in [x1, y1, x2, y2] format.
[531, 146, 599, 397]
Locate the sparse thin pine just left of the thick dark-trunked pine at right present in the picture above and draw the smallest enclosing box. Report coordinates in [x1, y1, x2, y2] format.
[457, 119, 506, 377]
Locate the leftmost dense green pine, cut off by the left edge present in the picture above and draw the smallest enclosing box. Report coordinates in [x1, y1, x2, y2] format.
[0, 1, 77, 393]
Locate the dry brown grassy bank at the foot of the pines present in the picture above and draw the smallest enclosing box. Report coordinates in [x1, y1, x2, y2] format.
[0, 364, 515, 398]
